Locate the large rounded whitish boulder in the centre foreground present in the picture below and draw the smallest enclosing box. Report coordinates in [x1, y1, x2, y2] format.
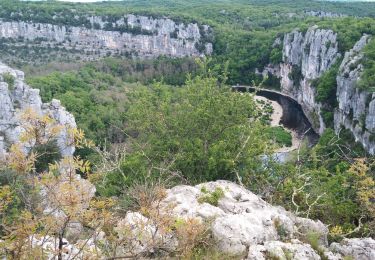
[162, 181, 328, 255]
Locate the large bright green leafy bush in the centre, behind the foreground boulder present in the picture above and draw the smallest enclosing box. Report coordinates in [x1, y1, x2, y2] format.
[97, 71, 267, 193]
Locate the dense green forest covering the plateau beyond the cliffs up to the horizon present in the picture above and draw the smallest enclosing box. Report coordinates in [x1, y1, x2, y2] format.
[0, 0, 375, 84]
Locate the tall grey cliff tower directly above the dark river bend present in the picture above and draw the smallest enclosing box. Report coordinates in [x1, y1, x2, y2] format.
[280, 26, 341, 133]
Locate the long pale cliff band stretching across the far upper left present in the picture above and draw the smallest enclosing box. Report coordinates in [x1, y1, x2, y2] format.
[0, 14, 212, 63]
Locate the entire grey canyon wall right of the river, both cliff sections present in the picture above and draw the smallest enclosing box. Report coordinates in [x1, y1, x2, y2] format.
[263, 26, 375, 154]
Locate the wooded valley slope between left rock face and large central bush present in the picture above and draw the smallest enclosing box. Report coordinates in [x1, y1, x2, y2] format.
[27, 57, 196, 144]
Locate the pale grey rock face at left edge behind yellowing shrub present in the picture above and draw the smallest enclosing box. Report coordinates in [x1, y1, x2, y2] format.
[0, 63, 76, 158]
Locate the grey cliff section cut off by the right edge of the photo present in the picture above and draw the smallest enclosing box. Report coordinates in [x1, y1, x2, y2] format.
[335, 35, 375, 154]
